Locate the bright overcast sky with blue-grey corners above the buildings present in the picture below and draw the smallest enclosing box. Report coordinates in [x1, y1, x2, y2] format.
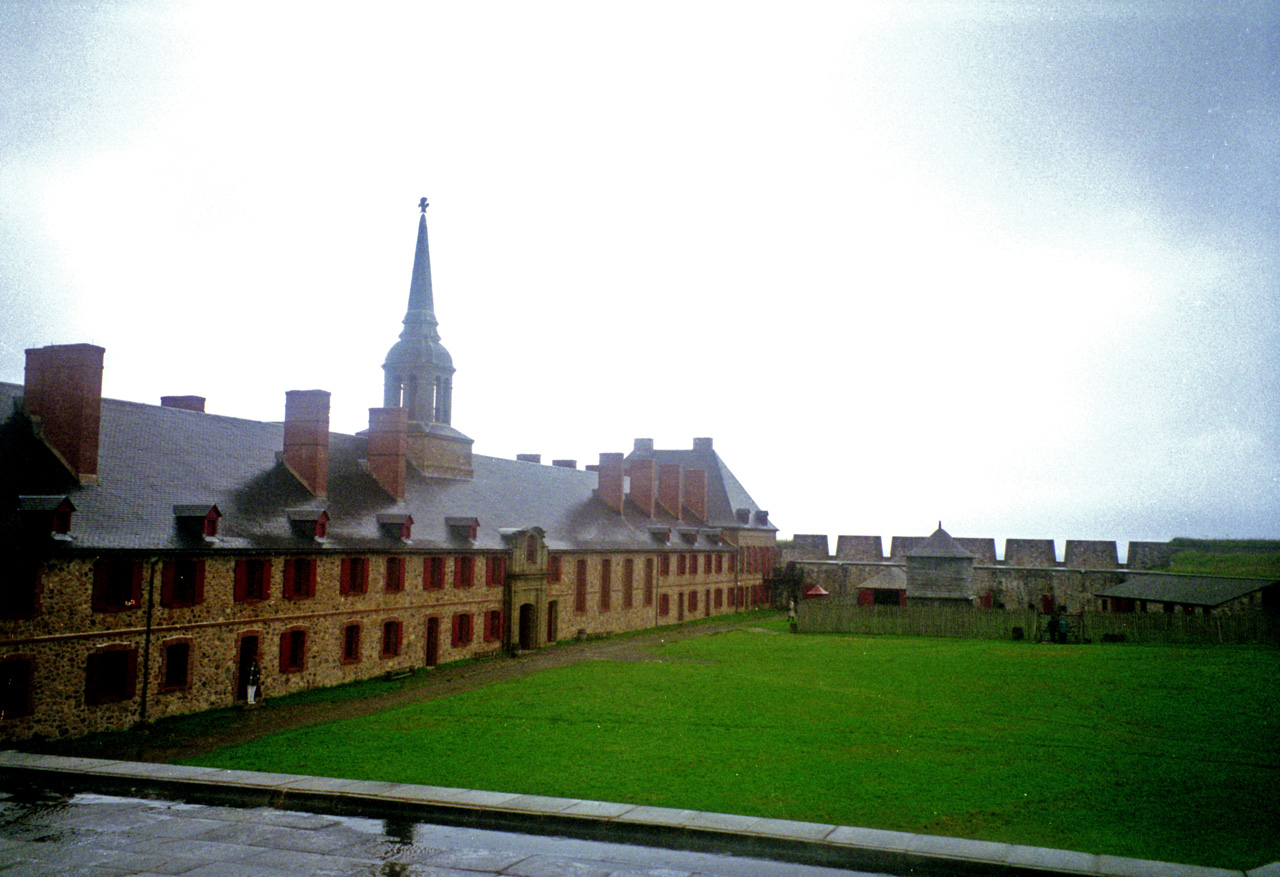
[0, 0, 1280, 554]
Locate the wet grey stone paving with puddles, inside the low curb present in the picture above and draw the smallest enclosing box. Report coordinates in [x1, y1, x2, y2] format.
[0, 791, 875, 877]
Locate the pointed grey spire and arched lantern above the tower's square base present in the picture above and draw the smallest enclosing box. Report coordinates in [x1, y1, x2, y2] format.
[383, 198, 454, 425]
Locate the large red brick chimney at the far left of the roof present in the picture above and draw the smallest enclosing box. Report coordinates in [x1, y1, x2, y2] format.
[23, 344, 106, 484]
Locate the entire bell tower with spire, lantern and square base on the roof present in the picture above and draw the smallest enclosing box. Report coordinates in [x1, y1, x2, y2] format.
[383, 198, 472, 479]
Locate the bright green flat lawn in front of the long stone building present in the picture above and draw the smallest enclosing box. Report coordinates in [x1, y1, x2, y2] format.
[185, 622, 1280, 868]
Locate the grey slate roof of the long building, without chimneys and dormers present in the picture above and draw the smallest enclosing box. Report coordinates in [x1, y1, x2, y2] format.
[0, 383, 773, 552]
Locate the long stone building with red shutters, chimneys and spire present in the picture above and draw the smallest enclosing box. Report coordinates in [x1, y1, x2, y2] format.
[0, 204, 776, 739]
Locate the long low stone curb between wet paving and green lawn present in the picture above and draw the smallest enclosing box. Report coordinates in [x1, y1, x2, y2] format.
[0, 752, 1259, 877]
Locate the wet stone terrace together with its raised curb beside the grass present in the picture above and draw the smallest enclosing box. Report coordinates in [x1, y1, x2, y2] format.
[0, 752, 1259, 877]
